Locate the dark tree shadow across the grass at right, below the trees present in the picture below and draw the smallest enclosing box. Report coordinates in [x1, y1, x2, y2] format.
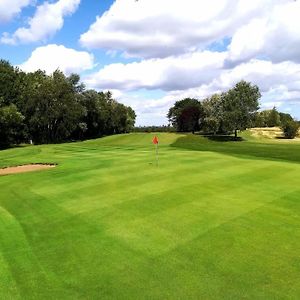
[171, 134, 300, 163]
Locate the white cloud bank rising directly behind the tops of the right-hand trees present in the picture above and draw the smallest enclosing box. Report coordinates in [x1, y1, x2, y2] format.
[169, 59, 300, 108]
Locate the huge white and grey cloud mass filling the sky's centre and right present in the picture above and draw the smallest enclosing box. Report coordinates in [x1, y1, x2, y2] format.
[80, 0, 300, 123]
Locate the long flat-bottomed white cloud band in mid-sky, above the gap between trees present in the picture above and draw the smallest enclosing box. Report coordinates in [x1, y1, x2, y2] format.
[85, 51, 226, 91]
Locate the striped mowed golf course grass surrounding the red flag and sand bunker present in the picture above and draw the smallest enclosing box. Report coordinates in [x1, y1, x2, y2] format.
[0, 134, 300, 299]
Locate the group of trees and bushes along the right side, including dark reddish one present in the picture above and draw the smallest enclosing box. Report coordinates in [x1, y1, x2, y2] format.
[167, 80, 299, 138]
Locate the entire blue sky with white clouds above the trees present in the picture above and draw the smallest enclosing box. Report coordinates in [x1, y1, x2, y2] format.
[0, 0, 300, 125]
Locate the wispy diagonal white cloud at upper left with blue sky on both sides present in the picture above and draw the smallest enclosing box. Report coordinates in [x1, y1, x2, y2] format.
[1, 0, 80, 45]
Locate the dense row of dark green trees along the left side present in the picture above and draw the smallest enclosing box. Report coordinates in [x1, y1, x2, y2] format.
[0, 60, 136, 146]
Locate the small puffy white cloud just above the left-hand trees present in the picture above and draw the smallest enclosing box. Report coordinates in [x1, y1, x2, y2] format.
[19, 45, 94, 75]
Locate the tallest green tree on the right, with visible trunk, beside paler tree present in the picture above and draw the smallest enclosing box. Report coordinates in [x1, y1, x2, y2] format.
[222, 80, 261, 138]
